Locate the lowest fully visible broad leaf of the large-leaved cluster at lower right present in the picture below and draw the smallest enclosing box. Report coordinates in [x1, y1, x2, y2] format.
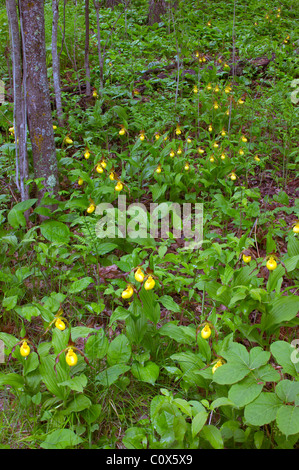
[244, 392, 282, 426]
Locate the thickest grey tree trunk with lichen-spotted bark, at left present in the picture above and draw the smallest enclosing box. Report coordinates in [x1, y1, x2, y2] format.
[19, 0, 59, 205]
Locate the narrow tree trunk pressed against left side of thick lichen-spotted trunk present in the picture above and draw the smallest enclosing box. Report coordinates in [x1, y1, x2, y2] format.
[6, 0, 29, 201]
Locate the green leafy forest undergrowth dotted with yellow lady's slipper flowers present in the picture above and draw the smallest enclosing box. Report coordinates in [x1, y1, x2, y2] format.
[0, 1, 299, 449]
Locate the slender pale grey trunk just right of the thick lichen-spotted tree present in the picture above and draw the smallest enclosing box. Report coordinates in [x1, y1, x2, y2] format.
[52, 0, 64, 127]
